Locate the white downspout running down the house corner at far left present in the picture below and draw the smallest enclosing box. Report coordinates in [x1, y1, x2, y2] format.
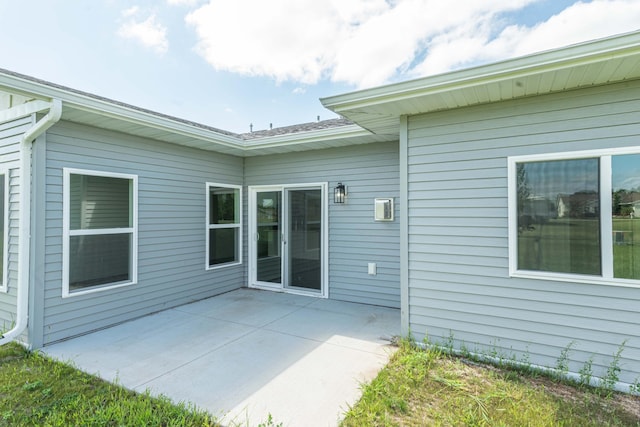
[0, 99, 62, 345]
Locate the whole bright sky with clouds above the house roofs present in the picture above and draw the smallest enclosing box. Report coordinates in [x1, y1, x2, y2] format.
[0, 0, 640, 132]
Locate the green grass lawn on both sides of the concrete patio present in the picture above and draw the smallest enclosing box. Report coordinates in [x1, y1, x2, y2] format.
[0, 342, 640, 427]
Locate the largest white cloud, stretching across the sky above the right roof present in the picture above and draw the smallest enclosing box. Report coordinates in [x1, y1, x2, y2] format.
[182, 0, 640, 87]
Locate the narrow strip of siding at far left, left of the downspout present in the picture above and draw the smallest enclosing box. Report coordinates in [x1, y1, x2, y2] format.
[0, 117, 28, 331]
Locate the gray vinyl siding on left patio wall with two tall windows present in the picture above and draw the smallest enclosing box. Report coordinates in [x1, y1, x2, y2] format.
[42, 122, 245, 344]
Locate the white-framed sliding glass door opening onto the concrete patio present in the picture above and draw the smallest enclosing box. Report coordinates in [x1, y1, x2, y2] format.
[249, 184, 326, 296]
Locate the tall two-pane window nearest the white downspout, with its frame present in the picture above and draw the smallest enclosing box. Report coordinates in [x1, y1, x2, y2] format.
[63, 169, 138, 296]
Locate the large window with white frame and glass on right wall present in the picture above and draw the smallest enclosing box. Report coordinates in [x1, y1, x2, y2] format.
[509, 151, 640, 284]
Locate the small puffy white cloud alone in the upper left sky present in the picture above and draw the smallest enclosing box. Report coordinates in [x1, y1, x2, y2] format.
[117, 6, 169, 55]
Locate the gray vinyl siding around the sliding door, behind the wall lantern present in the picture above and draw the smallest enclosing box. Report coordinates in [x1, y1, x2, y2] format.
[245, 142, 402, 307]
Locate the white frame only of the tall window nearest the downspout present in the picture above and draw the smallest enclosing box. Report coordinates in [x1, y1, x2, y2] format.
[62, 168, 138, 298]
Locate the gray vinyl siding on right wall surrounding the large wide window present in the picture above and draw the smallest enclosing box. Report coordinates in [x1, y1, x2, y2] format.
[401, 81, 640, 383]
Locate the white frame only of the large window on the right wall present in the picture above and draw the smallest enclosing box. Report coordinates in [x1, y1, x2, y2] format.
[507, 146, 640, 288]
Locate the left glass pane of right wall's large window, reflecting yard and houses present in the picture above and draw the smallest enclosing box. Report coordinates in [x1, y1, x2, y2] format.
[516, 159, 601, 275]
